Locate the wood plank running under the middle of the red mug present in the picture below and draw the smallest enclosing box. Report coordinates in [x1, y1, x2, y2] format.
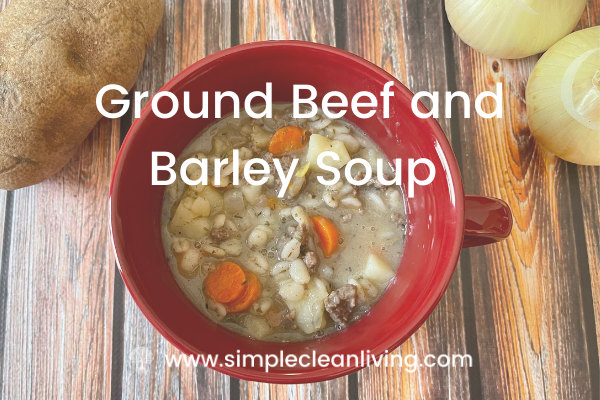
[234, 0, 348, 399]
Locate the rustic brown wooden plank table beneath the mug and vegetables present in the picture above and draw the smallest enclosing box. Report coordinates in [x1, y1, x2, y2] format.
[0, 0, 600, 400]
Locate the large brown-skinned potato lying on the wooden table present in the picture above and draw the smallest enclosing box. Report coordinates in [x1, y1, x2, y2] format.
[0, 0, 163, 190]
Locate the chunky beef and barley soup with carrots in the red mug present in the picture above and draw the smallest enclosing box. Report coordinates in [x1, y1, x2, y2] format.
[162, 104, 406, 341]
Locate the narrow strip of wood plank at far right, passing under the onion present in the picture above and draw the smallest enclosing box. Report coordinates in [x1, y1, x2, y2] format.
[577, 0, 600, 366]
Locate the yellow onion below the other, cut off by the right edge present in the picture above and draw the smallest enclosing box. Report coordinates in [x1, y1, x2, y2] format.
[526, 26, 600, 165]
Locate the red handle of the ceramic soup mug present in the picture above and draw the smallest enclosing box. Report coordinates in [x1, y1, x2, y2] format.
[462, 196, 513, 248]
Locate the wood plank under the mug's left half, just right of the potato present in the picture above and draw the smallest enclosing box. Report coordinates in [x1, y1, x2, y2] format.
[117, 0, 231, 399]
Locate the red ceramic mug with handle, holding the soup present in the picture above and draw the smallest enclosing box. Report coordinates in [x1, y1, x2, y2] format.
[110, 41, 512, 383]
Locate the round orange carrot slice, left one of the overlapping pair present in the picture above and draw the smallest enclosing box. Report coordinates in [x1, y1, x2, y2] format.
[204, 261, 247, 303]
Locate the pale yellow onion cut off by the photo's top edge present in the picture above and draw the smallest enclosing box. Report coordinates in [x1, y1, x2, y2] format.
[445, 0, 587, 58]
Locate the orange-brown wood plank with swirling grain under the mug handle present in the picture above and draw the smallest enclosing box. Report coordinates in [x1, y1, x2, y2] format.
[454, 4, 592, 399]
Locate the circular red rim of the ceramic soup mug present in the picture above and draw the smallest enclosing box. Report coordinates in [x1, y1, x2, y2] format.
[109, 40, 465, 383]
